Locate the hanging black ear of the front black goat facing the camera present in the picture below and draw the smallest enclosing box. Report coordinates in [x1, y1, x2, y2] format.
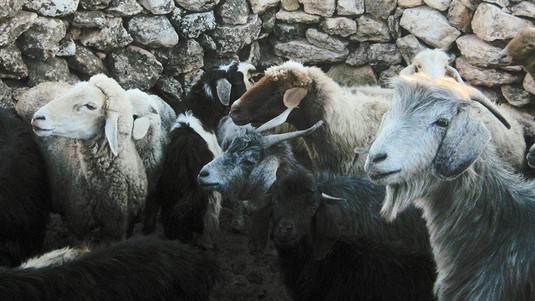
[312, 202, 342, 260]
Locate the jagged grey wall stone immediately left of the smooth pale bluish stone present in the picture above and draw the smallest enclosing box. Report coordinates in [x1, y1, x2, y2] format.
[80, 18, 134, 51]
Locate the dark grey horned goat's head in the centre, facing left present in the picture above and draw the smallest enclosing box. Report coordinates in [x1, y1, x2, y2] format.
[198, 108, 323, 204]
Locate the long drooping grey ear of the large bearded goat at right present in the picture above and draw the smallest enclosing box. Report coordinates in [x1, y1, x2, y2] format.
[433, 111, 490, 180]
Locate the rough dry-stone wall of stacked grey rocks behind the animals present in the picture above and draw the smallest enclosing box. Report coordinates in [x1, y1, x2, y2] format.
[0, 0, 535, 108]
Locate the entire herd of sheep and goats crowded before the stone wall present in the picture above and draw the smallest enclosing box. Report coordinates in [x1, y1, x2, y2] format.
[0, 28, 535, 301]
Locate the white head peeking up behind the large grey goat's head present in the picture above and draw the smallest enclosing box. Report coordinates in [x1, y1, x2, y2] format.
[399, 49, 464, 84]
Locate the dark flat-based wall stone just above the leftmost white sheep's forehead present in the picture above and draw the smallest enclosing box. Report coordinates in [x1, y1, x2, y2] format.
[26, 58, 79, 87]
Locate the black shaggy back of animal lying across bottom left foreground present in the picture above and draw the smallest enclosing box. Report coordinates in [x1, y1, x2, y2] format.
[0, 238, 219, 301]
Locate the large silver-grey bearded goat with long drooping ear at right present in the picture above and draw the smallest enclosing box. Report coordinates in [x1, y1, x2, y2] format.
[365, 75, 535, 300]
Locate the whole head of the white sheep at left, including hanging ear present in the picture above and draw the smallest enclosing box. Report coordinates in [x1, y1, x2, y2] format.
[32, 74, 133, 155]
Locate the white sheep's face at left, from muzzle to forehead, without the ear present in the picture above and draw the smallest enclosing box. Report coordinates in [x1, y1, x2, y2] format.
[32, 82, 105, 139]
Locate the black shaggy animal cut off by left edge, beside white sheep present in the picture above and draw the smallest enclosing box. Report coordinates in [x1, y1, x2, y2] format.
[0, 108, 51, 266]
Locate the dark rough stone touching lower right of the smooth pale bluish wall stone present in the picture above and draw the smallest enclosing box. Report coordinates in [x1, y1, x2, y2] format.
[155, 39, 204, 75]
